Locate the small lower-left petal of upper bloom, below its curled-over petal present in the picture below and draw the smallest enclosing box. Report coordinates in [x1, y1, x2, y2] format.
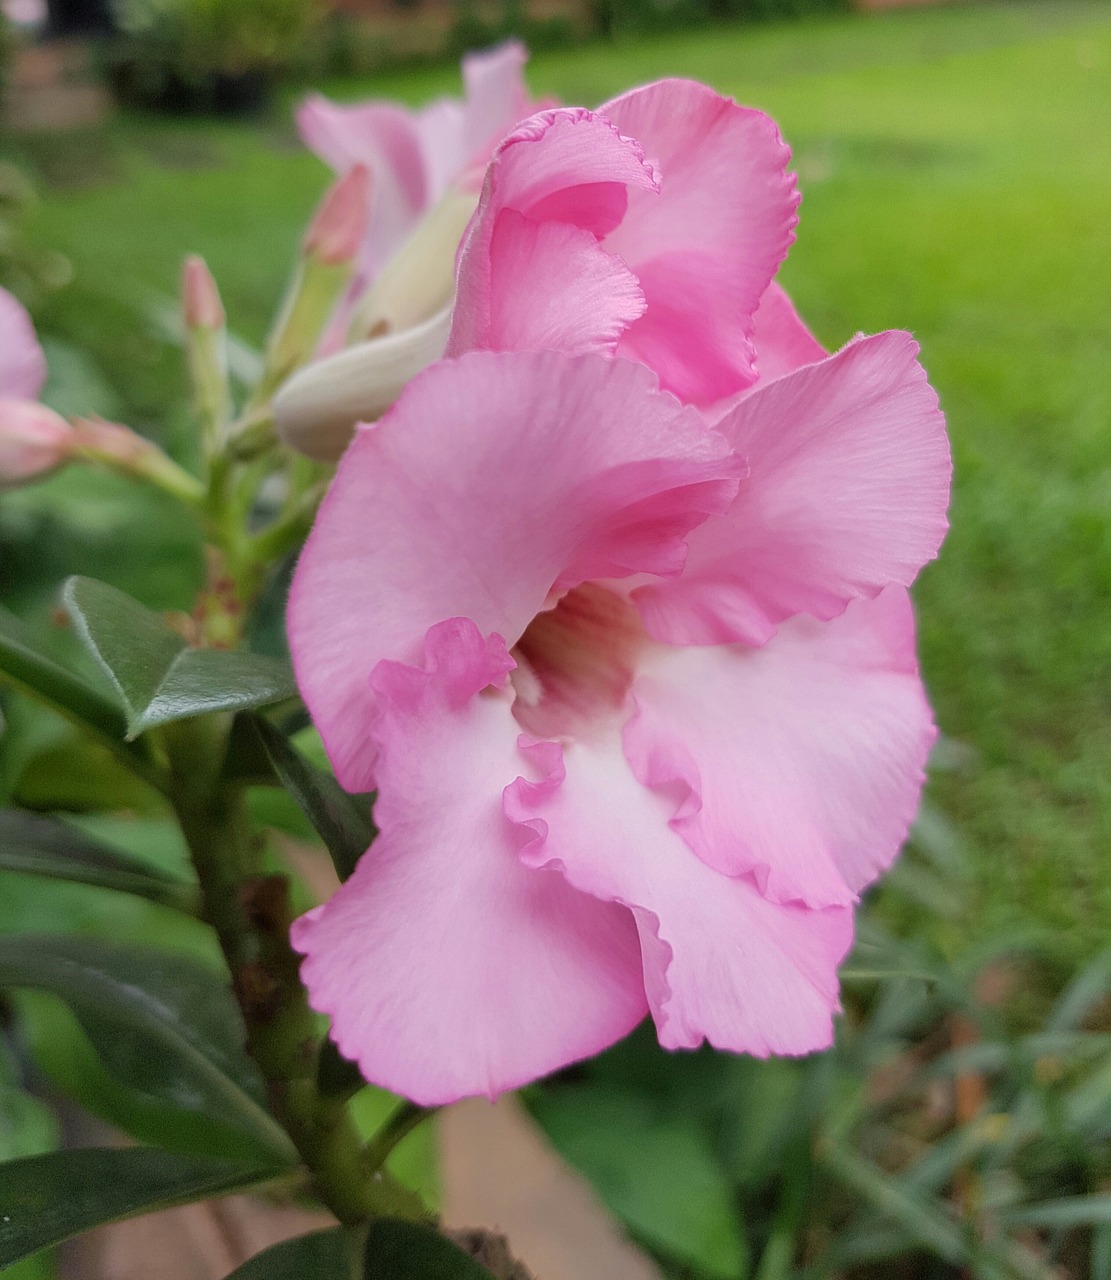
[451, 209, 644, 355]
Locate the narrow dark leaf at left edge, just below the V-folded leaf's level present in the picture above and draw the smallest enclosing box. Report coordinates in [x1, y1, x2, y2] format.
[0, 809, 198, 915]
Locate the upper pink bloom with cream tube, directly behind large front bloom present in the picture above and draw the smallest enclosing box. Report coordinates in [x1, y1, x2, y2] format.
[276, 79, 808, 461]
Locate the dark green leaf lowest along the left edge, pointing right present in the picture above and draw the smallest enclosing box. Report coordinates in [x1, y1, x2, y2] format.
[0, 1147, 282, 1267]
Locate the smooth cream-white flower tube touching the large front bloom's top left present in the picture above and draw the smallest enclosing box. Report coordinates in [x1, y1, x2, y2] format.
[274, 306, 452, 462]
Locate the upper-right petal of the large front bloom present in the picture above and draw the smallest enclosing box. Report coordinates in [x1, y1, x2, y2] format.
[634, 332, 952, 645]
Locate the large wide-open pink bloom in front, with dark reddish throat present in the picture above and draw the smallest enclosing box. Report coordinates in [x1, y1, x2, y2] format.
[289, 337, 950, 1103]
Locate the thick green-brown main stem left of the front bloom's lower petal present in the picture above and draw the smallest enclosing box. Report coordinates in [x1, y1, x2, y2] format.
[165, 716, 422, 1225]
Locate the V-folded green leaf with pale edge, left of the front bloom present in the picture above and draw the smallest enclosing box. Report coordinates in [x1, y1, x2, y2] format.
[63, 577, 297, 740]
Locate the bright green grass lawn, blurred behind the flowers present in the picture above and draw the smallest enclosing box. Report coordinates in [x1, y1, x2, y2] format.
[5, 0, 1111, 948]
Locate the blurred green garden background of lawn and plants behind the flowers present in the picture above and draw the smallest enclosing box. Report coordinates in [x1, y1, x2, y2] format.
[0, 0, 1111, 1280]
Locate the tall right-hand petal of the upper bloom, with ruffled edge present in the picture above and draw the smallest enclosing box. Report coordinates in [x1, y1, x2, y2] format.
[599, 79, 799, 404]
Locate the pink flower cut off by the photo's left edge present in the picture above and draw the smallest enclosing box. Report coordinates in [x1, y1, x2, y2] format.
[0, 289, 73, 489]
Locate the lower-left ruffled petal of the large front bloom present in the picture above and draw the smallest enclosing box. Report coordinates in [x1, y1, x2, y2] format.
[292, 618, 646, 1106]
